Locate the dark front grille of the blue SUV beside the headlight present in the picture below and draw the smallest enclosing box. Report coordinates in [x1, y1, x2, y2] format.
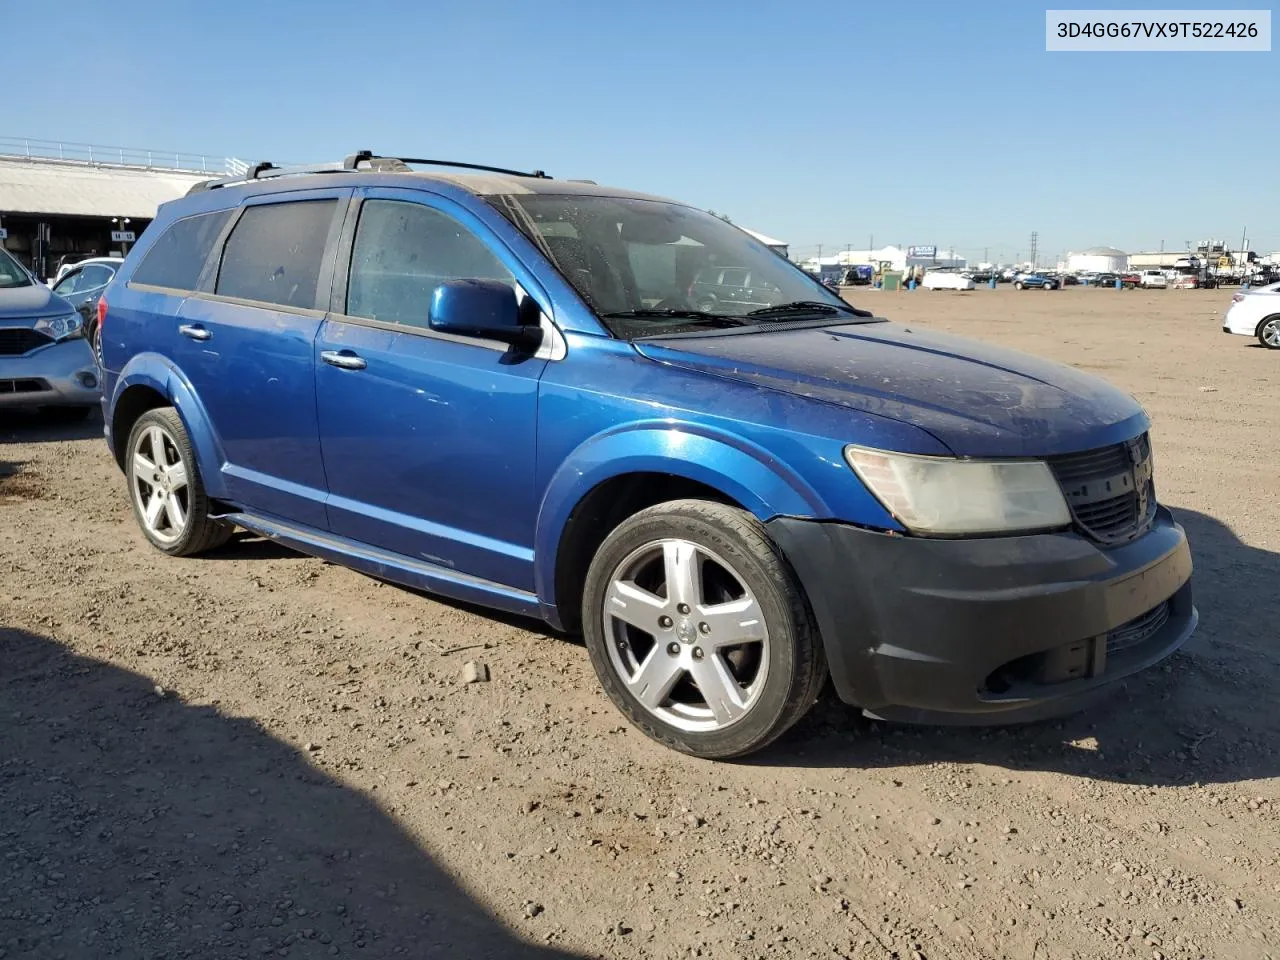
[1048, 434, 1156, 544]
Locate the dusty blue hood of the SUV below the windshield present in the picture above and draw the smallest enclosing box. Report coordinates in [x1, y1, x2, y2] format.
[635, 323, 1148, 457]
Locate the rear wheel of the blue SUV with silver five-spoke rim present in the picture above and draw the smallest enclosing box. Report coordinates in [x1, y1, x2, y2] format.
[124, 407, 232, 557]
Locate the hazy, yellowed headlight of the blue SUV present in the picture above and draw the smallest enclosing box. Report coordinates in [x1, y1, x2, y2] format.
[845, 445, 1071, 535]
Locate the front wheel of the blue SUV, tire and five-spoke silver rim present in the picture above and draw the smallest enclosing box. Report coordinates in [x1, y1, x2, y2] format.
[582, 500, 827, 759]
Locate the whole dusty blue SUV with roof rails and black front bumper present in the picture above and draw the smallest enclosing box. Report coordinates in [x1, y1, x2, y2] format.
[99, 152, 1197, 758]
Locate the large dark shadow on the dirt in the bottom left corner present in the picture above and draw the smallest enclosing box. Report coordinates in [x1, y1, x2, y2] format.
[0, 628, 588, 960]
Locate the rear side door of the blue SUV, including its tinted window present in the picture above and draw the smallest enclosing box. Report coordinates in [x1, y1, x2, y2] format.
[174, 189, 351, 529]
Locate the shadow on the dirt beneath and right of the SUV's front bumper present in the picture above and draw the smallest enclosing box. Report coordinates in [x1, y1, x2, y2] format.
[768, 509, 1280, 786]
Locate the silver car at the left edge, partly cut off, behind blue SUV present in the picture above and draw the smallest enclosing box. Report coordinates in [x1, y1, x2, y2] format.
[0, 248, 99, 420]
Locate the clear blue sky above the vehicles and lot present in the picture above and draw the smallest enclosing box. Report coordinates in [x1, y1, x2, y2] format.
[0, 0, 1280, 259]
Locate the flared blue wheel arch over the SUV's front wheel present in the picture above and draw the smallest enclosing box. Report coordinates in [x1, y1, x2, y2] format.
[534, 420, 831, 608]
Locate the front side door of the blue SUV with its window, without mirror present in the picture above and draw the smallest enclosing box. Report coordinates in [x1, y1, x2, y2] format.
[315, 189, 547, 590]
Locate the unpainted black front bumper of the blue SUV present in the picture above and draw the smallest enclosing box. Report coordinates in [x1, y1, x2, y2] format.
[768, 507, 1197, 723]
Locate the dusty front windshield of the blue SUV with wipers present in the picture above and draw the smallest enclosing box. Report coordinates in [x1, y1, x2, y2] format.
[495, 193, 861, 339]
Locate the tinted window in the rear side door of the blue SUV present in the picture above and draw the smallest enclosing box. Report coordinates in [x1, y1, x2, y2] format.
[214, 200, 338, 310]
